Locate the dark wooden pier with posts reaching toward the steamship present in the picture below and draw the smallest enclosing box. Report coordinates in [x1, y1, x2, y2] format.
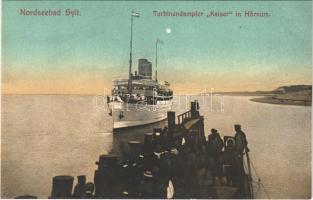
[17, 101, 253, 199]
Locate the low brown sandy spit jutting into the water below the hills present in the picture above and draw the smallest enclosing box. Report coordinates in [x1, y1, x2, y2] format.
[250, 96, 312, 106]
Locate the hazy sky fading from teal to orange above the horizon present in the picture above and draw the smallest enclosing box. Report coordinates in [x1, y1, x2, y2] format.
[2, 1, 312, 94]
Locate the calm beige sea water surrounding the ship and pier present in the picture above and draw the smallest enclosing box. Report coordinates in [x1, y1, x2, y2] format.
[1, 95, 311, 198]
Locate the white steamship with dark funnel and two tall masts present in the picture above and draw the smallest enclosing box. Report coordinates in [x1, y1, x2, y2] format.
[107, 12, 173, 129]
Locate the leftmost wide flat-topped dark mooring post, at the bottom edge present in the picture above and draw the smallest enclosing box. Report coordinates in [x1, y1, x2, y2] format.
[50, 176, 74, 199]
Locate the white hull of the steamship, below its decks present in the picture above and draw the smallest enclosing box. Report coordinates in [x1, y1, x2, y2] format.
[109, 100, 172, 129]
